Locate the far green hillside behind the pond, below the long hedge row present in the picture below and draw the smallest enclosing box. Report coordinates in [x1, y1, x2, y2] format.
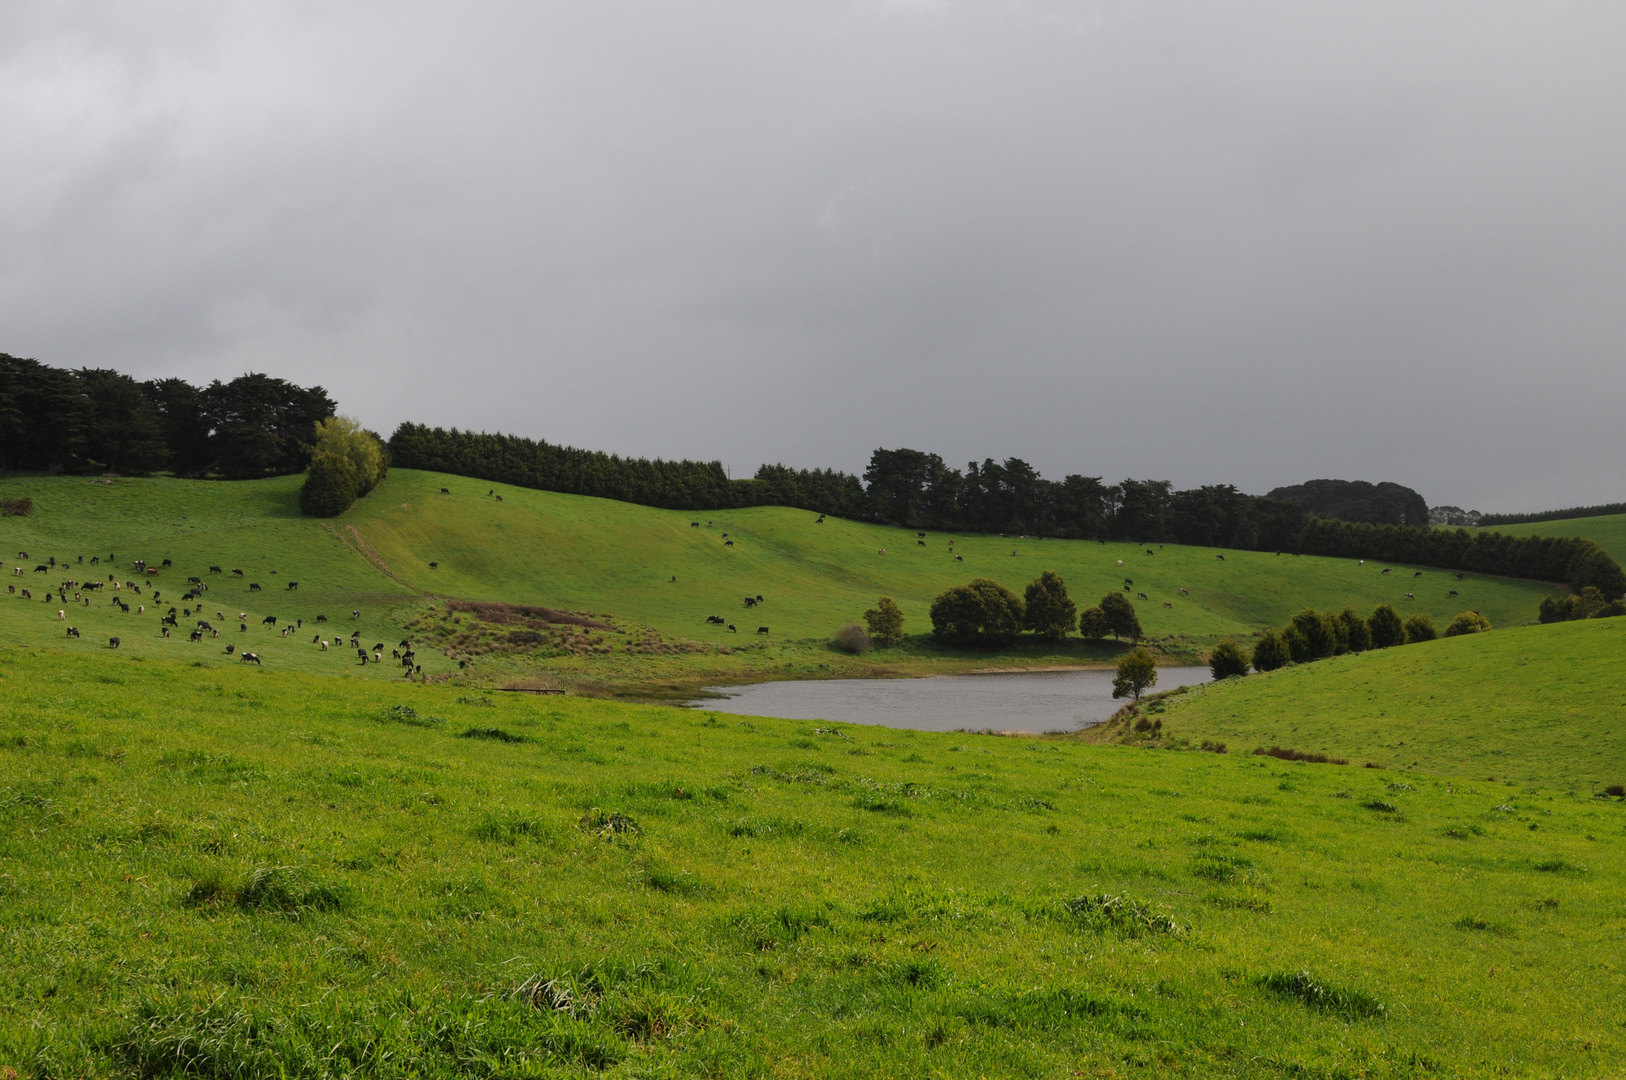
[0, 470, 1553, 693]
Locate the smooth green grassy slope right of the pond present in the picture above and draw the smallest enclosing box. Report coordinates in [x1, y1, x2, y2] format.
[1163, 618, 1626, 795]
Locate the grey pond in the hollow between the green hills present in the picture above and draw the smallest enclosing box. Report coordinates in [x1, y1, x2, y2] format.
[689, 667, 1211, 734]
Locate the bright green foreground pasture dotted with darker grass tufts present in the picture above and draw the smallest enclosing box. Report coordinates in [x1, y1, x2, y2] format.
[0, 644, 1626, 1077]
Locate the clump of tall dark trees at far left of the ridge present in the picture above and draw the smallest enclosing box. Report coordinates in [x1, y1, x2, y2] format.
[0, 353, 335, 480]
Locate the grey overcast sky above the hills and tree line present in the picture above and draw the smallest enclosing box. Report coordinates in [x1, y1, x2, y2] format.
[0, 0, 1626, 511]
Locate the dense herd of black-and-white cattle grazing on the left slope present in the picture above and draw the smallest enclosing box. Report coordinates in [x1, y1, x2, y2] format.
[8, 551, 423, 678]
